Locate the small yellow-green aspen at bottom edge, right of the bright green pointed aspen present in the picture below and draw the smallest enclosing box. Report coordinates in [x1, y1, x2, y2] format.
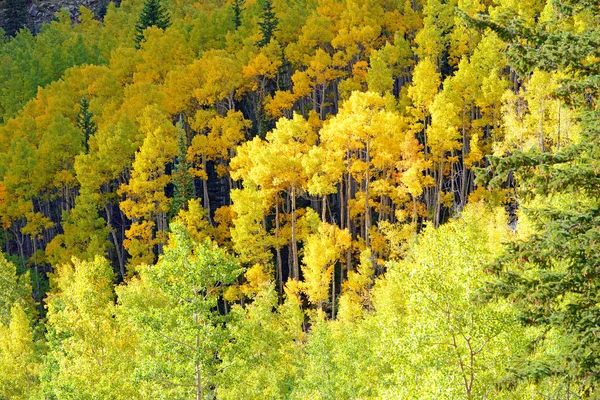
[217, 284, 304, 400]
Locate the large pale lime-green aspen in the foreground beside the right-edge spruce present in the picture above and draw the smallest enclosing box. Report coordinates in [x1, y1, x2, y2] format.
[374, 205, 531, 399]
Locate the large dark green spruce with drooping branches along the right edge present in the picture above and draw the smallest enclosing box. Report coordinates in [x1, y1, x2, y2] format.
[471, 0, 600, 398]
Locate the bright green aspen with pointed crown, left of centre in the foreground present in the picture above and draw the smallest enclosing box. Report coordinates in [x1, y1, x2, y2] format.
[117, 224, 241, 399]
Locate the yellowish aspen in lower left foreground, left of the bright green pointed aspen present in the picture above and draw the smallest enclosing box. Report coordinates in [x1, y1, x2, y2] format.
[42, 257, 135, 399]
